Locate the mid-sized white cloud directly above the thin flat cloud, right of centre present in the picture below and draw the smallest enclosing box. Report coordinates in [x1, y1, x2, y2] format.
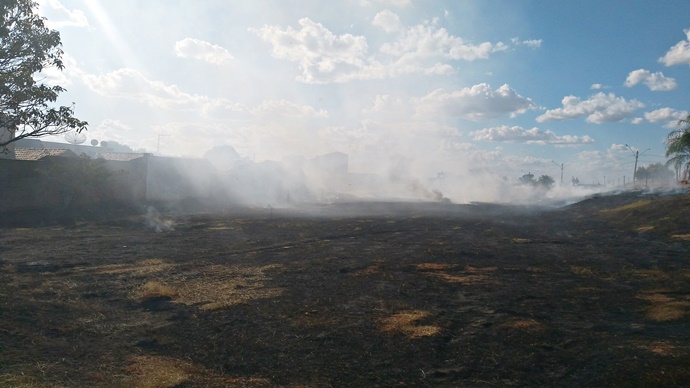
[417, 83, 536, 121]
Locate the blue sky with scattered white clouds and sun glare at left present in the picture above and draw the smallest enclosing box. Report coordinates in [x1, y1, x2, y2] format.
[39, 0, 690, 183]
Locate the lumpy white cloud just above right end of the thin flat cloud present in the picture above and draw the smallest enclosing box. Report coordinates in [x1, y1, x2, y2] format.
[536, 92, 645, 124]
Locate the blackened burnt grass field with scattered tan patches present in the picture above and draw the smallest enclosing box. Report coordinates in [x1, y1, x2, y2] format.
[0, 193, 690, 387]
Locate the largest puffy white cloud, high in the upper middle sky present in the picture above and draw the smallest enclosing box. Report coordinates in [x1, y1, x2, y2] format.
[250, 17, 508, 84]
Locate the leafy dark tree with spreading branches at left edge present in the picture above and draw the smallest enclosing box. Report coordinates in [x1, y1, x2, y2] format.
[0, 0, 88, 152]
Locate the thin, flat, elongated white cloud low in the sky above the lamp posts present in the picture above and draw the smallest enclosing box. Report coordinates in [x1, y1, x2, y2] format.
[471, 125, 594, 145]
